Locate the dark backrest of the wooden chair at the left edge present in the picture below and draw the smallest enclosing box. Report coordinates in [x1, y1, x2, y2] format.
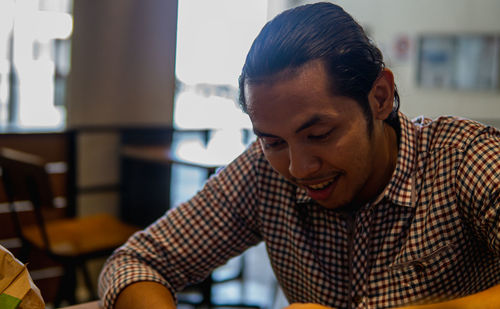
[0, 148, 54, 248]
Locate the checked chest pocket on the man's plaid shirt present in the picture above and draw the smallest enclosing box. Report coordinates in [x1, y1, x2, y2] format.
[389, 243, 458, 290]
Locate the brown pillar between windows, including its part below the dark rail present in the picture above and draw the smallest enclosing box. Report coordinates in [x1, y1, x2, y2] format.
[67, 0, 177, 215]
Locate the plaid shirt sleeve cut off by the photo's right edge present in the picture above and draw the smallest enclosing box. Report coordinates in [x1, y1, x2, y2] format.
[457, 128, 500, 256]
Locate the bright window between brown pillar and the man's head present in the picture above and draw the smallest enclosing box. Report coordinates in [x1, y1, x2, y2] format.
[171, 0, 267, 205]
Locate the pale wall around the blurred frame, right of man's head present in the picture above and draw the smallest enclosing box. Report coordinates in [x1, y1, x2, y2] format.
[291, 0, 500, 128]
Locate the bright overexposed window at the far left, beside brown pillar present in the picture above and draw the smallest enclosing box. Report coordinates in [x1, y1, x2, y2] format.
[0, 0, 73, 128]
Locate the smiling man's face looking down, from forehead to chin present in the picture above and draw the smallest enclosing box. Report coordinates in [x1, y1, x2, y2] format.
[245, 62, 392, 209]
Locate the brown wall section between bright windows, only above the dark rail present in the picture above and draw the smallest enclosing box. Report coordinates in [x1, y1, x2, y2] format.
[67, 0, 177, 128]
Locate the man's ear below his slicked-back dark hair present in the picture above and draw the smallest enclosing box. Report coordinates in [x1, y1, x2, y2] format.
[368, 68, 395, 120]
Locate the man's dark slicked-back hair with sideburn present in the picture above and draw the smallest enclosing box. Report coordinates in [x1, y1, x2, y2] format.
[239, 3, 399, 128]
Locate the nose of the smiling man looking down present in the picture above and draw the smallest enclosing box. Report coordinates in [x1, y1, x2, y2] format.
[288, 147, 321, 179]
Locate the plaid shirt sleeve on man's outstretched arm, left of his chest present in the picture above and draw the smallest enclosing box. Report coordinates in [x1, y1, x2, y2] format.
[99, 144, 261, 308]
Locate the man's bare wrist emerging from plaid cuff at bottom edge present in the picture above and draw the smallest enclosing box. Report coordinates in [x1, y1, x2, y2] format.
[115, 281, 176, 309]
